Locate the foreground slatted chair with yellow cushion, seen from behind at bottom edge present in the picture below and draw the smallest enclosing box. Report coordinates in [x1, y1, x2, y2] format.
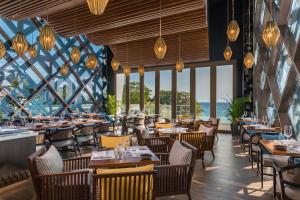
[93, 165, 156, 200]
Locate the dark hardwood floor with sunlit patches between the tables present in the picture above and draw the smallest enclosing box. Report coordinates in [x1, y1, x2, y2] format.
[0, 134, 272, 200]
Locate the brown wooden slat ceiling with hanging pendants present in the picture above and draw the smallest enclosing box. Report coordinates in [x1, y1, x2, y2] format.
[0, 0, 208, 66]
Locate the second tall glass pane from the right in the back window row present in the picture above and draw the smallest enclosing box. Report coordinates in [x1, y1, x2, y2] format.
[195, 67, 210, 120]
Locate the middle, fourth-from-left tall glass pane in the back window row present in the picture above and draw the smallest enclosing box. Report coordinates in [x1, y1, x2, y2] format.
[159, 70, 172, 119]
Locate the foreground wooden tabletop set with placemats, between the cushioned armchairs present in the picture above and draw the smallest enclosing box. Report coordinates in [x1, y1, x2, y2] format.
[89, 146, 160, 169]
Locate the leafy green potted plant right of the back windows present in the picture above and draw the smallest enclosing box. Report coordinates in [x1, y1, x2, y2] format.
[225, 97, 250, 136]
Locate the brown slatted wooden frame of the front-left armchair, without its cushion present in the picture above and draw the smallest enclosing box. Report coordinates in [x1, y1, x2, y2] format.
[27, 148, 92, 200]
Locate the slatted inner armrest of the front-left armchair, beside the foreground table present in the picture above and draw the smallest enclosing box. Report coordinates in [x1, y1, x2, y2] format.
[64, 157, 91, 172]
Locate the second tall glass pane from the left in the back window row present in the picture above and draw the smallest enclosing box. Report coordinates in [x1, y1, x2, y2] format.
[129, 73, 140, 114]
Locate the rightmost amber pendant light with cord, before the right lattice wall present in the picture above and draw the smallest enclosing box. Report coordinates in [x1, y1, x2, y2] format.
[262, 1, 280, 48]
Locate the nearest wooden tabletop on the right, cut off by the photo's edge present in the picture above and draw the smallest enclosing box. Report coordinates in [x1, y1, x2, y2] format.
[259, 140, 300, 157]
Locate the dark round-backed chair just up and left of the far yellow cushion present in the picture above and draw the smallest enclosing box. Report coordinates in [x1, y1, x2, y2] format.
[74, 124, 97, 146]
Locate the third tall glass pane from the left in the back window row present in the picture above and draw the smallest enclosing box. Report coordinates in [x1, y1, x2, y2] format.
[144, 72, 155, 114]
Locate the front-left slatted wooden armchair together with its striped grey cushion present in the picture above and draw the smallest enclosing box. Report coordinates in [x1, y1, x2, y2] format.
[27, 145, 92, 200]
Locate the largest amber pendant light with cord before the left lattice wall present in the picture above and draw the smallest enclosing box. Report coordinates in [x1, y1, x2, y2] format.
[39, 1, 55, 51]
